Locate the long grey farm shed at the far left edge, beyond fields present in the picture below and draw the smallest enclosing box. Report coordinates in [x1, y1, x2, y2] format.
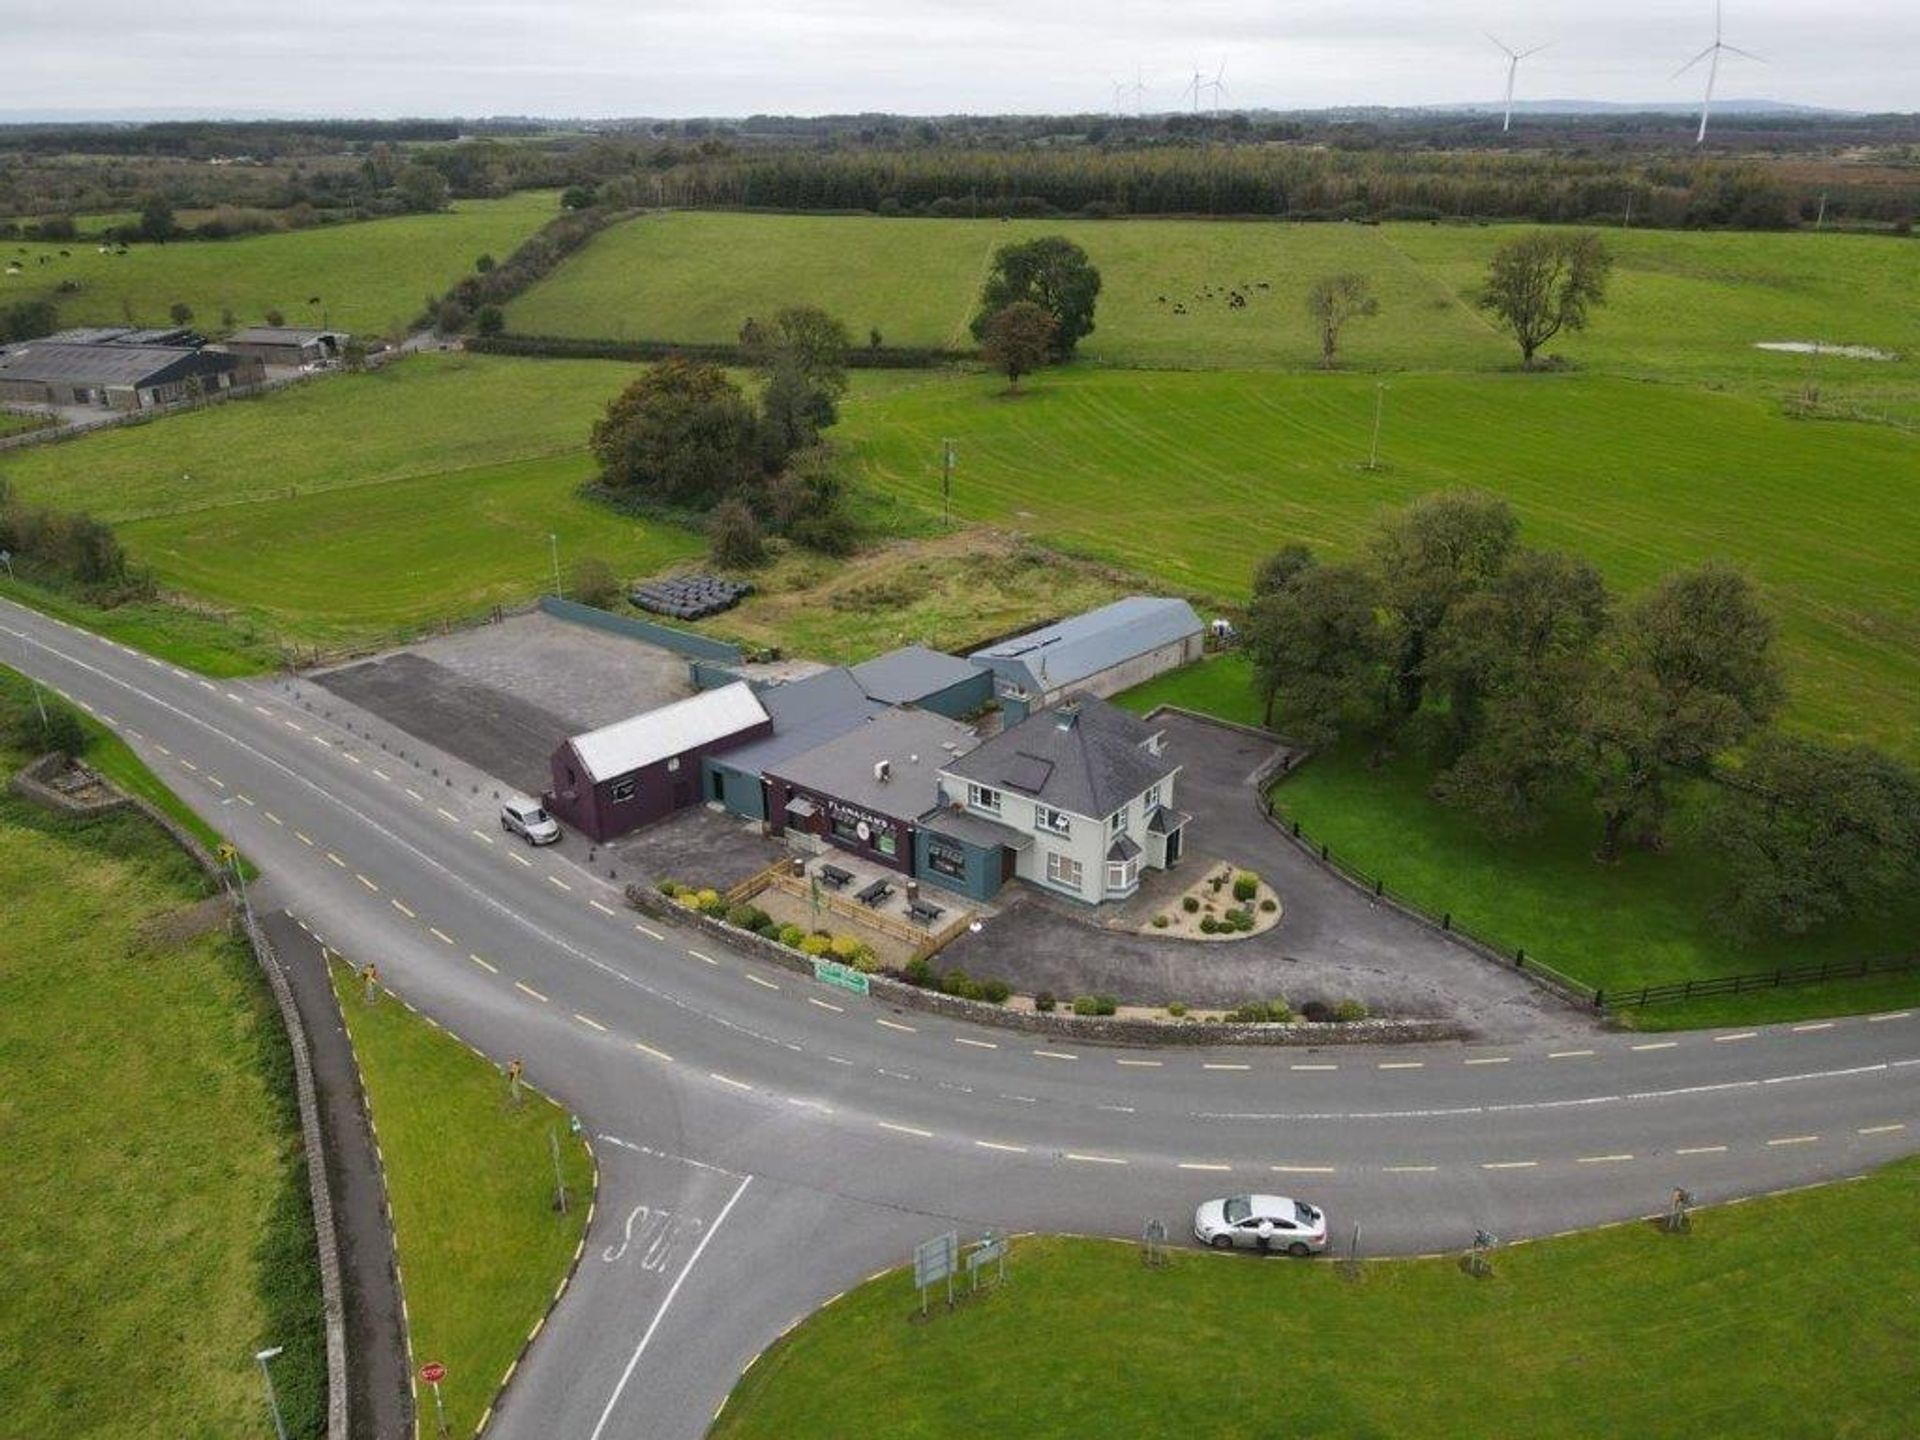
[0, 340, 261, 411]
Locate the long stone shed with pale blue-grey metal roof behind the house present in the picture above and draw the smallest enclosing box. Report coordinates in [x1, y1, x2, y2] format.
[972, 595, 1206, 720]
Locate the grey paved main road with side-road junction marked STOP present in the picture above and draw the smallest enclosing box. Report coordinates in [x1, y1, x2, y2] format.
[0, 605, 1920, 1440]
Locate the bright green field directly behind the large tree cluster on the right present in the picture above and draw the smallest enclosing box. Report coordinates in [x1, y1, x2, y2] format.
[841, 367, 1920, 756]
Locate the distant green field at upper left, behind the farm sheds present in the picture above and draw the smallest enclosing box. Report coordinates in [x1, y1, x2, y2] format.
[0, 190, 559, 336]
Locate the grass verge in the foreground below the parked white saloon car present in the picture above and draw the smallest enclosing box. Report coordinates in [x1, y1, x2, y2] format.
[710, 1160, 1920, 1440]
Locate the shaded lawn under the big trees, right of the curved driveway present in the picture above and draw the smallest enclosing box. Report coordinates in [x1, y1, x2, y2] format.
[1121, 655, 1920, 1029]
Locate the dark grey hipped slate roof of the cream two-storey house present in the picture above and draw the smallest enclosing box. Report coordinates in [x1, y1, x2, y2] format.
[947, 697, 1179, 820]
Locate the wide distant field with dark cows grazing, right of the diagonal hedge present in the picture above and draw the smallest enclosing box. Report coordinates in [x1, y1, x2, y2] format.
[507, 213, 1920, 392]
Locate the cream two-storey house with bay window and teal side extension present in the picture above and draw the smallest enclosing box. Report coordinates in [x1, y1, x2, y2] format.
[920, 697, 1190, 904]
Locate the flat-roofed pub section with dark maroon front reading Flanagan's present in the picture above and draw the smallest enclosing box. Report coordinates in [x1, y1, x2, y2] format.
[766, 710, 979, 876]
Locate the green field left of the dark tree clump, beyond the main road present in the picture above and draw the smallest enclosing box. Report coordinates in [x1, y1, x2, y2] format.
[0, 355, 703, 643]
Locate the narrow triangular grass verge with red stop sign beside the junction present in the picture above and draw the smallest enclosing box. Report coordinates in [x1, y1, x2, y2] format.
[334, 964, 593, 1434]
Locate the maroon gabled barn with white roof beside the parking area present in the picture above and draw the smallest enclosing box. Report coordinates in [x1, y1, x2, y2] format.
[545, 680, 774, 841]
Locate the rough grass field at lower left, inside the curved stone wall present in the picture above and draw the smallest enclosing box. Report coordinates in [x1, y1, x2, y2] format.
[0, 672, 326, 1440]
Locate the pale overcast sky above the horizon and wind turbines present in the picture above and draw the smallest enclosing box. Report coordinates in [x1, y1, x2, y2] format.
[0, 0, 1920, 117]
